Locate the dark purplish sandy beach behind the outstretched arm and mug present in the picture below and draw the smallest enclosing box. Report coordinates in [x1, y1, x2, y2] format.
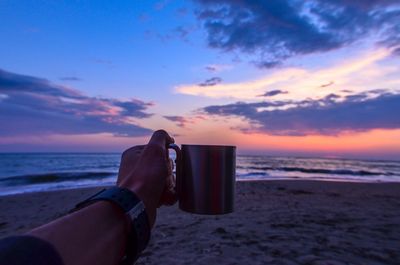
[0, 178, 400, 265]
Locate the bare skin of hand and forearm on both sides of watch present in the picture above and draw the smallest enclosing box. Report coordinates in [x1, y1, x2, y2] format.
[28, 130, 176, 265]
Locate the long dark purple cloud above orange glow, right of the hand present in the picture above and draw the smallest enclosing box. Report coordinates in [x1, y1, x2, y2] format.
[203, 91, 400, 135]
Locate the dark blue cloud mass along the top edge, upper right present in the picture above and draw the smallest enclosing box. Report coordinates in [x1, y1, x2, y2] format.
[195, 0, 400, 68]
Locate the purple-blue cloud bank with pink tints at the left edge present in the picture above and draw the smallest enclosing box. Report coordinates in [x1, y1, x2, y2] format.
[0, 70, 152, 136]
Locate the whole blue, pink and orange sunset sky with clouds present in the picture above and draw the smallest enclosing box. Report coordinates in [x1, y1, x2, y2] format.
[0, 0, 400, 160]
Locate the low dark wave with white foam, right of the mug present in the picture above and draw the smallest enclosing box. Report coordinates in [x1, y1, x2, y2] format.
[238, 166, 395, 176]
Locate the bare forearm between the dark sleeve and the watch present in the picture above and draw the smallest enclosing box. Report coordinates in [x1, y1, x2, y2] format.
[29, 201, 130, 265]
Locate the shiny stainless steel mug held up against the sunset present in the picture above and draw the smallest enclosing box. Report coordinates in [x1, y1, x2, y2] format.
[169, 144, 236, 214]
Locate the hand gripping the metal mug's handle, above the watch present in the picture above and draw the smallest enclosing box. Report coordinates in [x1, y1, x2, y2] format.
[117, 130, 177, 226]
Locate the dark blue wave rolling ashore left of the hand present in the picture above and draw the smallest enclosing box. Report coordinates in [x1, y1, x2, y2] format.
[0, 172, 117, 186]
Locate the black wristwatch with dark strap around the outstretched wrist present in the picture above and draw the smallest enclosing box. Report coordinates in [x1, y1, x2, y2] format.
[74, 187, 150, 264]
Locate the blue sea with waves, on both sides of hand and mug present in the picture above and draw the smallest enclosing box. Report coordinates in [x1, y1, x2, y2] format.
[0, 153, 400, 195]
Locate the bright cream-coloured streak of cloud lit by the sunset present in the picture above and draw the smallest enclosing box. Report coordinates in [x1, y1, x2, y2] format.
[175, 48, 400, 100]
